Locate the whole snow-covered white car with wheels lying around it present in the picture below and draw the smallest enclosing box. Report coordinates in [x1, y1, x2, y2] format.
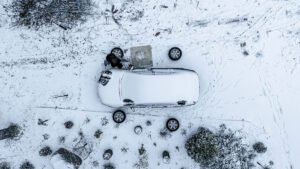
[98, 68, 200, 107]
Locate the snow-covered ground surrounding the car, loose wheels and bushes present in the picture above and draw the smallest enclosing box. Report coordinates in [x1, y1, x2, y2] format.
[0, 0, 300, 169]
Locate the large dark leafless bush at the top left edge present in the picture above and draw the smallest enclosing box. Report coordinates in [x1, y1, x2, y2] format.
[7, 0, 93, 29]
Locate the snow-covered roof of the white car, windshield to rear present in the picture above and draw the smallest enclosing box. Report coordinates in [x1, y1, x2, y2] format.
[120, 69, 199, 105]
